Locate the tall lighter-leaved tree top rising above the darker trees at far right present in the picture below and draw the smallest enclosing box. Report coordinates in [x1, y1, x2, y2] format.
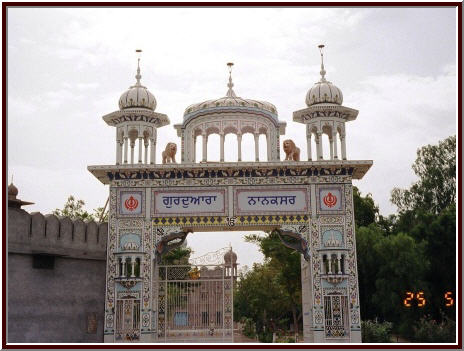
[391, 135, 456, 214]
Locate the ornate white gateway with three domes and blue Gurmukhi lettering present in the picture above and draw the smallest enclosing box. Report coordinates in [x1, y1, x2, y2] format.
[88, 45, 372, 343]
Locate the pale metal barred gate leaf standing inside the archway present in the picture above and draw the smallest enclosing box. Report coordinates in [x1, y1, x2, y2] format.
[158, 249, 234, 343]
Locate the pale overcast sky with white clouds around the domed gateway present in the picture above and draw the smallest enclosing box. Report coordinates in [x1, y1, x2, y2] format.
[7, 8, 457, 267]
